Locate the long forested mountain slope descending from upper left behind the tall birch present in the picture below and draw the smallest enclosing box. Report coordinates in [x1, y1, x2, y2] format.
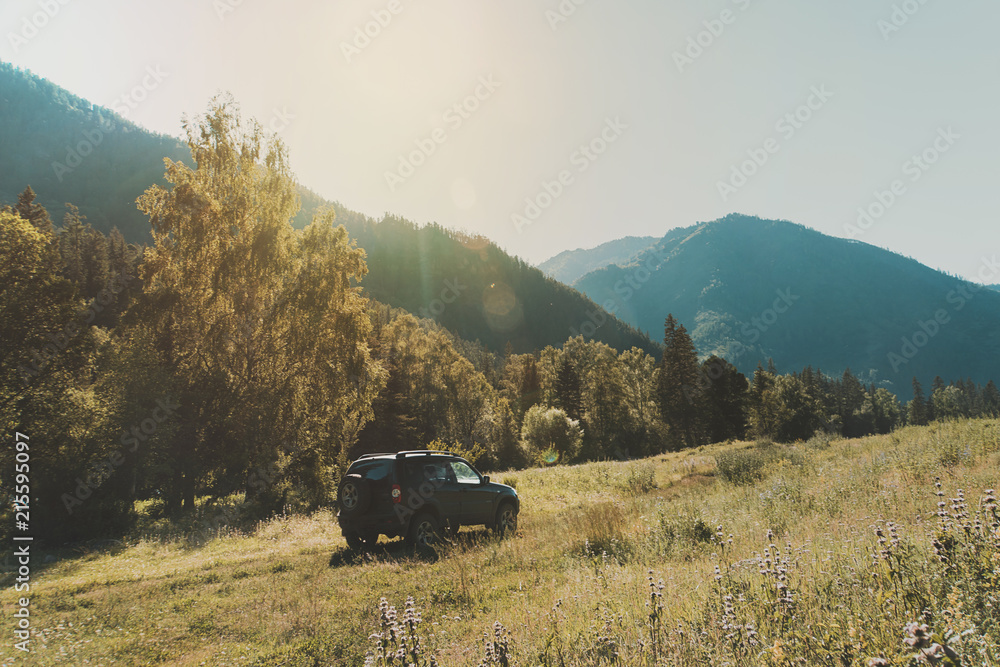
[0, 63, 659, 354]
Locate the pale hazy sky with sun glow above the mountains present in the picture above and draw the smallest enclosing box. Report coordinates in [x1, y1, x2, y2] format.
[0, 0, 1000, 280]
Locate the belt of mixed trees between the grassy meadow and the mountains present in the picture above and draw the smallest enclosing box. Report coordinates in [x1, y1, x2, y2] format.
[0, 100, 1000, 543]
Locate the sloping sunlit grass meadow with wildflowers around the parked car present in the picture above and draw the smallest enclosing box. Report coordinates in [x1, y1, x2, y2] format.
[0, 421, 1000, 667]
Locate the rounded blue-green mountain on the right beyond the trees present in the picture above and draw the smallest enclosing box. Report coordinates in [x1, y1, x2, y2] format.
[574, 215, 1000, 396]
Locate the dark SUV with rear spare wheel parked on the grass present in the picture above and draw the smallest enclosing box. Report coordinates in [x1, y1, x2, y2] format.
[337, 450, 521, 550]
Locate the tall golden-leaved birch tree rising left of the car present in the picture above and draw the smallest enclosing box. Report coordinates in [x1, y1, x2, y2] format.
[132, 98, 384, 507]
